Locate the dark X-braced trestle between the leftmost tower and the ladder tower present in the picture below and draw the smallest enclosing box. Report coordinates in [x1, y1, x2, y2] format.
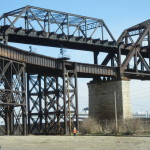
[27, 73, 64, 134]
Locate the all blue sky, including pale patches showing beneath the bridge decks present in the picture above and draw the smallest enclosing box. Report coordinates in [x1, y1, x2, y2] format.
[0, 0, 150, 112]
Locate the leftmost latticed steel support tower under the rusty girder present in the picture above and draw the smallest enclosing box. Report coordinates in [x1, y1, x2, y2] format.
[0, 58, 26, 135]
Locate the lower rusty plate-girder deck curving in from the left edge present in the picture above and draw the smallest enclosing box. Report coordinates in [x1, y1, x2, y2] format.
[0, 43, 117, 78]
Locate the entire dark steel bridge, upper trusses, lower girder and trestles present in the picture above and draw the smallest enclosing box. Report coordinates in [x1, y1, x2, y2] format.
[0, 6, 150, 135]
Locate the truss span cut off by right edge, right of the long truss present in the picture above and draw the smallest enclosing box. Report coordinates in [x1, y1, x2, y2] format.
[117, 20, 150, 77]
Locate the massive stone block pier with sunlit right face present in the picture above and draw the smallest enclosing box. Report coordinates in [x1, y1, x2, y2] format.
[88, 80, 132, 120]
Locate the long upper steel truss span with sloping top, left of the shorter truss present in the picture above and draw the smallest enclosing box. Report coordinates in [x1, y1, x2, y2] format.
[0, 6, 116, 51]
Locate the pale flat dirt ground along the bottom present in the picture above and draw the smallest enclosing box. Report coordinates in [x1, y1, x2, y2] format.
[0, 136, 150, 150]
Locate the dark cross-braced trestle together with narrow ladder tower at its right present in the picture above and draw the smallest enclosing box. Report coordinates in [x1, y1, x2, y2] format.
[27, 63, 78, 134]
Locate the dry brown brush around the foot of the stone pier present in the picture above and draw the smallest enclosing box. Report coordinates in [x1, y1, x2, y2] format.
[80, 118, 150, 134]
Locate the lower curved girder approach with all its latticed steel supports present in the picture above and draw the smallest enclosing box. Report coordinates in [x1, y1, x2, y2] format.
[0, 44, 117, 134]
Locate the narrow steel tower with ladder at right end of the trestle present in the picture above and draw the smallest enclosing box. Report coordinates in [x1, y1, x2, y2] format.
[64, 63, 79, 134]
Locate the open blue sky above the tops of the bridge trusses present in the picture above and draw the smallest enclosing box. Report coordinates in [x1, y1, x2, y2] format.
[0, 0, 150, 38]
